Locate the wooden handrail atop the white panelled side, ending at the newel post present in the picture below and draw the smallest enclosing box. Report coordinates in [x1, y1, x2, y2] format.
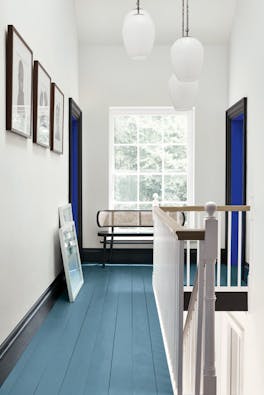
[153, 206, 205, 240]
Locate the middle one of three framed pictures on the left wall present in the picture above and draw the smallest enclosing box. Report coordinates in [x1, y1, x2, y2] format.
[33, 60, 51, 148]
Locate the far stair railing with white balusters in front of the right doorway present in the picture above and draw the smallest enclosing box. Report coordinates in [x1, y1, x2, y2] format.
[160, 205, 251, 292]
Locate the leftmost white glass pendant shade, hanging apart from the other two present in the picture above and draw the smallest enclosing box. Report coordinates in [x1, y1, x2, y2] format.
[123, 9, 155, 60]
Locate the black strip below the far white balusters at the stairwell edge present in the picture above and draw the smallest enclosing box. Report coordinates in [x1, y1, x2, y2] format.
[184, 292, 248, 311]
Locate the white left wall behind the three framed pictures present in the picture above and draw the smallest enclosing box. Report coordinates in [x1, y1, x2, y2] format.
[0, 0, 78, 343]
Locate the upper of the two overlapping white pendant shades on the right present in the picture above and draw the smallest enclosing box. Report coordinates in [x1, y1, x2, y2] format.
[171, 37, 204, 82]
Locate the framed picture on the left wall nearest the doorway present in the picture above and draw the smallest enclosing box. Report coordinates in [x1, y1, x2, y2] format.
[50, 83, 64, 154]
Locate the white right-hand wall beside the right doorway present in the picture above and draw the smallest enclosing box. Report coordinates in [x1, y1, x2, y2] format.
[229, 0, 264, 395]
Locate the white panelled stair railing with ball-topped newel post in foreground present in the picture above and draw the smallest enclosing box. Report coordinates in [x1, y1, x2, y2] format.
[153, 203, 217, 395]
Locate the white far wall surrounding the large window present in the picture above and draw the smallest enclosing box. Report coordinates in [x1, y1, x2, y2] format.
[80, 44, 228, 248]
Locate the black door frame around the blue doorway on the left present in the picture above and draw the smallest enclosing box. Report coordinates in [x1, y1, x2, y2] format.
[69, 98, 83, 252]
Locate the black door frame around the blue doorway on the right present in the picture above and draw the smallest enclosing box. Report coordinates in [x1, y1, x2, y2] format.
[225, 97, 247, 277]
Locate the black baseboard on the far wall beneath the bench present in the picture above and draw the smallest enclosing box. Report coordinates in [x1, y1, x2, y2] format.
[81, 248, 153, 265]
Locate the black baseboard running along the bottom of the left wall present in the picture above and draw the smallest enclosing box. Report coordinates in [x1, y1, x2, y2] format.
[0, 273, 65, 386]
